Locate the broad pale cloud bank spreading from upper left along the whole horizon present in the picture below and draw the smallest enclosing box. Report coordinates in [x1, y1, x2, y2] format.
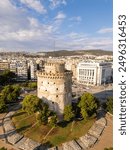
[0, 0, 112, 51]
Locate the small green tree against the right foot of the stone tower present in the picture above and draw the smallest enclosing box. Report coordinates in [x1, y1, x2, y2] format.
[64, 105, 75, 121]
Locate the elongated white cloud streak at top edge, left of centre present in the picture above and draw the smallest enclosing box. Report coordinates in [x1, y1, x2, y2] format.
[20, 0, 47, 13]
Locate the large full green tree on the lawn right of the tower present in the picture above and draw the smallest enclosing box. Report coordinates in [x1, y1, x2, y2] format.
[78, 93, 98, 119]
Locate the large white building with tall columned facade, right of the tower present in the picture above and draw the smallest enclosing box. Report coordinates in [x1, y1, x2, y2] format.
[77, 62, 112, 85]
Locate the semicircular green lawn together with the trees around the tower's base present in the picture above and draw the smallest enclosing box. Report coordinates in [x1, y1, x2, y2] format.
[12, 93, 98, 146]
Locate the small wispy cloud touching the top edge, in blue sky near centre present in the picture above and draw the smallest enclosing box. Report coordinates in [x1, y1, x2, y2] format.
[49, 0, 67, 9]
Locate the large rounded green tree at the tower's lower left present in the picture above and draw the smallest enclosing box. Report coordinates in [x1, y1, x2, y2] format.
[22, 95, 42, 114]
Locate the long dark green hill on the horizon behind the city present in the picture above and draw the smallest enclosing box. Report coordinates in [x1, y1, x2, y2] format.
[45, 50, 113, 57]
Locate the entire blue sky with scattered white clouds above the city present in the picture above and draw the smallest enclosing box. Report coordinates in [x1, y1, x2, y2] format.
[0, 0, 113, 52]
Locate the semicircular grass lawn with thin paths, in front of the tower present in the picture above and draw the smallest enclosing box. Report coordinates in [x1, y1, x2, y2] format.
[12, 110, 95, 146]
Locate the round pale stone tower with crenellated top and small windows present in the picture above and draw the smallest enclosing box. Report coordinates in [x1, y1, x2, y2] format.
[37, 62, 72, 115]
